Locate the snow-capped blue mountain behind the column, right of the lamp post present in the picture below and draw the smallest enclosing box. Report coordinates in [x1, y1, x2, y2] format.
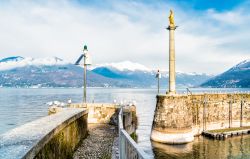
[92, 61, 212, 87]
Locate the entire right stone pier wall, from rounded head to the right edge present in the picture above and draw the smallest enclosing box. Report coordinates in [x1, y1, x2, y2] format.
[151, 94, 250, 143]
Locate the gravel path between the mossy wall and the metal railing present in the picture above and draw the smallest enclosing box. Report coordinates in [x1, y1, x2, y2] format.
[74, 124, 118, 159]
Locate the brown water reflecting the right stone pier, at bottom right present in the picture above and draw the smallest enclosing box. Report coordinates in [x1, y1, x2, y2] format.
[152, 135, 250, 159]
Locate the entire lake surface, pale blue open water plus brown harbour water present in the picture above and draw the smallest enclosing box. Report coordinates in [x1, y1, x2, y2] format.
[0, 88, 250, 159]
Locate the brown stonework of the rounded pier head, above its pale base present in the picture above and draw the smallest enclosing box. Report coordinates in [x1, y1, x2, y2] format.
[153, 96, 192, 133]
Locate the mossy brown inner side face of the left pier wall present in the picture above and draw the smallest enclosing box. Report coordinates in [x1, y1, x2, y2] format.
[33, 110, 88, 159]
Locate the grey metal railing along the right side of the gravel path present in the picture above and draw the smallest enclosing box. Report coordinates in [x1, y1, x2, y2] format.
[118, 108, 151, 159]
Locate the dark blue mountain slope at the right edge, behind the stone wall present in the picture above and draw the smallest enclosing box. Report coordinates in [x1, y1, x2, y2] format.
[201, 60, 250, 88]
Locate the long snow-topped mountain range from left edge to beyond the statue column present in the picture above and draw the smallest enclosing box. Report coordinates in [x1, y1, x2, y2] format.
[0, 56, 212, 88]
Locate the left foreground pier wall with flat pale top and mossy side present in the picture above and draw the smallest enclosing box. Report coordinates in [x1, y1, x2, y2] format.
[0, 108, 88, 159]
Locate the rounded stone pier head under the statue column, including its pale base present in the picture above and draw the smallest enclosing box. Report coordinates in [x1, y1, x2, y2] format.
[151, 95, 194, 144]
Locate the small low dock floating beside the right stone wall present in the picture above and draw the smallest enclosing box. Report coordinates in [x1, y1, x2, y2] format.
[202, 126, 250, 140]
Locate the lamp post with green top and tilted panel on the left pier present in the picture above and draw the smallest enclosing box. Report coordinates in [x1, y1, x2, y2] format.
[75, 45, 92, 103]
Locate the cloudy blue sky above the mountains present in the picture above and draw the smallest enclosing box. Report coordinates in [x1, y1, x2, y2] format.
[0, 0, 250, 74]
